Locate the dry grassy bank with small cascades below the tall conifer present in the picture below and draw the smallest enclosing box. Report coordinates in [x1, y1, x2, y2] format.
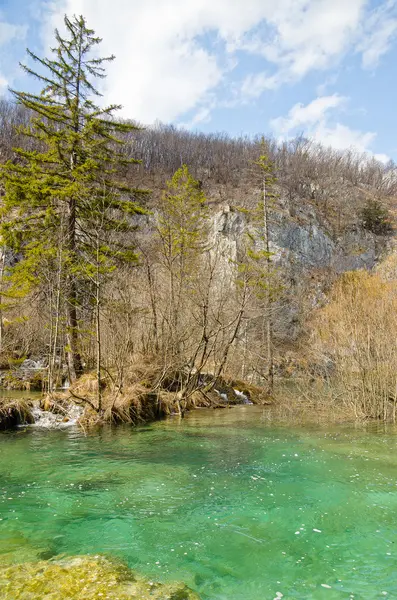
[0, 363, 271, 430]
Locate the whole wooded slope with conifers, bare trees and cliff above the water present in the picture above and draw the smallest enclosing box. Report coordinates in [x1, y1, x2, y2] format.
[0, 18, 397, 424]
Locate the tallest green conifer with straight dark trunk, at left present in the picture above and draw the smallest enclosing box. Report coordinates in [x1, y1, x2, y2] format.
[0, 16, 145, 379]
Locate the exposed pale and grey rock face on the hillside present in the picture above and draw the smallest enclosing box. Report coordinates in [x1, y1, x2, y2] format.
[207, 198, 391, 339]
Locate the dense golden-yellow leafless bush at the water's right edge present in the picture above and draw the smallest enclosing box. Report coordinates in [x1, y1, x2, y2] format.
[305, 271, 397, 422]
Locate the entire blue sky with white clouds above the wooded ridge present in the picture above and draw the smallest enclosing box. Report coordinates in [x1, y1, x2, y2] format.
[0, 0, 397, 162]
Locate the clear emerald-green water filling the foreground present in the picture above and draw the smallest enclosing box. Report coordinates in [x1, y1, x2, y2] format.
[0, 407, 397, 600]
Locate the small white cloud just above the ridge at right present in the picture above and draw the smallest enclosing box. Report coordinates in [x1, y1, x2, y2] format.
[270, 94, 389, 162]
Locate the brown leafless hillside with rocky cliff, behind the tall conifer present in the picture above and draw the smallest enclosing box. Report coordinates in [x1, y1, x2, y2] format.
[0, 100, 397, 412]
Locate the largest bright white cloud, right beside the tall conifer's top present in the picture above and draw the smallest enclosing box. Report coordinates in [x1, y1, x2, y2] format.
[42, 0, 282, 122]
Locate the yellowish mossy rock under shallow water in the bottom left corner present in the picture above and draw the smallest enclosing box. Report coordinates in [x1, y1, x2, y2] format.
[0, 556, 200, 600]
